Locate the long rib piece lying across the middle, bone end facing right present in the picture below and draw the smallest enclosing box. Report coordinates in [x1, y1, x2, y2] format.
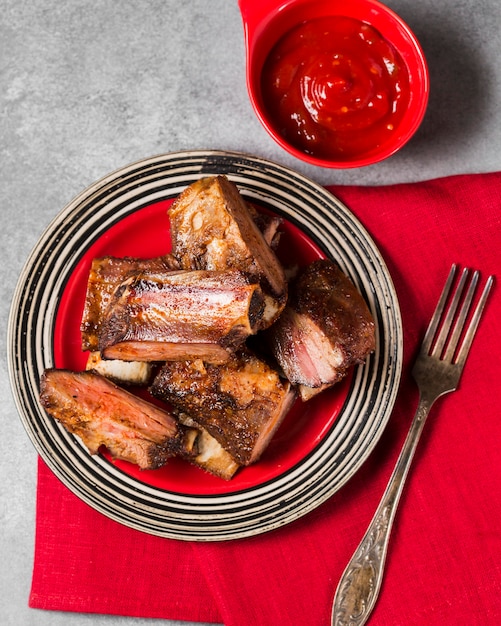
[95, 270, 263, 362]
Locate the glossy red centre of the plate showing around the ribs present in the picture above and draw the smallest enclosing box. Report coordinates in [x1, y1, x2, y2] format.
[50, 200, 350, 495]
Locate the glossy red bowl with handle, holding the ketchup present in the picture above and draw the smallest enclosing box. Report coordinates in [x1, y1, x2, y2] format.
[239, 0, 429, 168]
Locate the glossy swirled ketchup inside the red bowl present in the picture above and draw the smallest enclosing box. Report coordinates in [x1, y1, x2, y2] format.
[261, 16, 409, 160]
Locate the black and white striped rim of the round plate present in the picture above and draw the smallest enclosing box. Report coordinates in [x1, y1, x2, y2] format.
[8, 151, 402, 541]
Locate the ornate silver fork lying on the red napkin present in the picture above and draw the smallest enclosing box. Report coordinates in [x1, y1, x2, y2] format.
[331, 265, 494, 626]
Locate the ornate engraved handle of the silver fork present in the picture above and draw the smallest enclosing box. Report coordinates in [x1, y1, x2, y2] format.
[332, 395, 434, 626]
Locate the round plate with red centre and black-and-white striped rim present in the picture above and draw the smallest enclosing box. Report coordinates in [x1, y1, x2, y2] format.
[8, 151, 403, 541]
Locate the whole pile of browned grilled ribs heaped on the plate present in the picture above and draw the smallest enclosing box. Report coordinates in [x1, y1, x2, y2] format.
[40, 176, 375, 480]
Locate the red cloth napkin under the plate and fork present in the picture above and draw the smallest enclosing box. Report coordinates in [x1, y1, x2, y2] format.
[30, 173, 501, 626]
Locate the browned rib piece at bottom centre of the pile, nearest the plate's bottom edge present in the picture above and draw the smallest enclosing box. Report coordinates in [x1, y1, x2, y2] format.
[150, 349, 296, 465]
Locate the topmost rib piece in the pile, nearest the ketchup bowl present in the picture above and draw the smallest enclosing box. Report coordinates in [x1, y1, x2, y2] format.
[169, 176, 287, 328]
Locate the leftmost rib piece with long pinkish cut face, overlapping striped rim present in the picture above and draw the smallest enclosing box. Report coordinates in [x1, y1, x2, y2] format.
[40, 369, 181, 469]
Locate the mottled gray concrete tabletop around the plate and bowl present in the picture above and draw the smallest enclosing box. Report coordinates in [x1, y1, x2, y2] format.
[0, 0, 501, 626]
